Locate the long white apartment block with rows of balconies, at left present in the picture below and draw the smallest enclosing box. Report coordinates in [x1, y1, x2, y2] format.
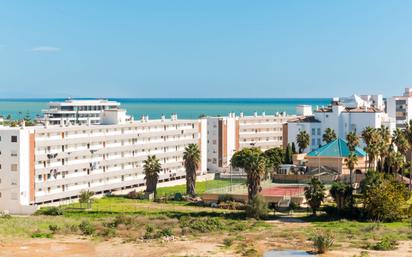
[0, 110, 207, 213]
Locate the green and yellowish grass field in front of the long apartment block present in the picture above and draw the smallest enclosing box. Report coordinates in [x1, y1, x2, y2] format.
[0, 180, 412, 256]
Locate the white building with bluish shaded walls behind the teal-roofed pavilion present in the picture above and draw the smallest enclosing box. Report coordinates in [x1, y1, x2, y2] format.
[287, 99, 395, 152]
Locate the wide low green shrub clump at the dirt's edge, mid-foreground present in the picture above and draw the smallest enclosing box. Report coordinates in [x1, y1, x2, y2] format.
[179, 217, 223, 233]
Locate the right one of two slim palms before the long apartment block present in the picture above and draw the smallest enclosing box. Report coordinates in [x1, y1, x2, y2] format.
[183, 144, 200, 196]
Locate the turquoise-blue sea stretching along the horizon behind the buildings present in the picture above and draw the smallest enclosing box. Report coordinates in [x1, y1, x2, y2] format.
[0, 98, 331, 119]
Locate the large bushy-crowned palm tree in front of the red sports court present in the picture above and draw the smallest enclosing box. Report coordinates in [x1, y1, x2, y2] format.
[230, 148, 266, 202]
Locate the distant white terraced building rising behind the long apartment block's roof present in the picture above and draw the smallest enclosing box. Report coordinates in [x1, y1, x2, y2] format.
[40, 99, 120, 125]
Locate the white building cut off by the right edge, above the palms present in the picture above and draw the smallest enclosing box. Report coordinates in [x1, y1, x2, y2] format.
[387, 88, 412, 128]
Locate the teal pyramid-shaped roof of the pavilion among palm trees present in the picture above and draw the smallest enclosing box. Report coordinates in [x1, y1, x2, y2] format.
[307, 138, 366, 158]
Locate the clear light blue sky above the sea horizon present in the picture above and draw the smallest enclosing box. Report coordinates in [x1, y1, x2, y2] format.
[0, 0, 412, 98]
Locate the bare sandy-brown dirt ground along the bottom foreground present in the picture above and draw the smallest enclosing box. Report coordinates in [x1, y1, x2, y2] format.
[0, 218, 412, 257]
